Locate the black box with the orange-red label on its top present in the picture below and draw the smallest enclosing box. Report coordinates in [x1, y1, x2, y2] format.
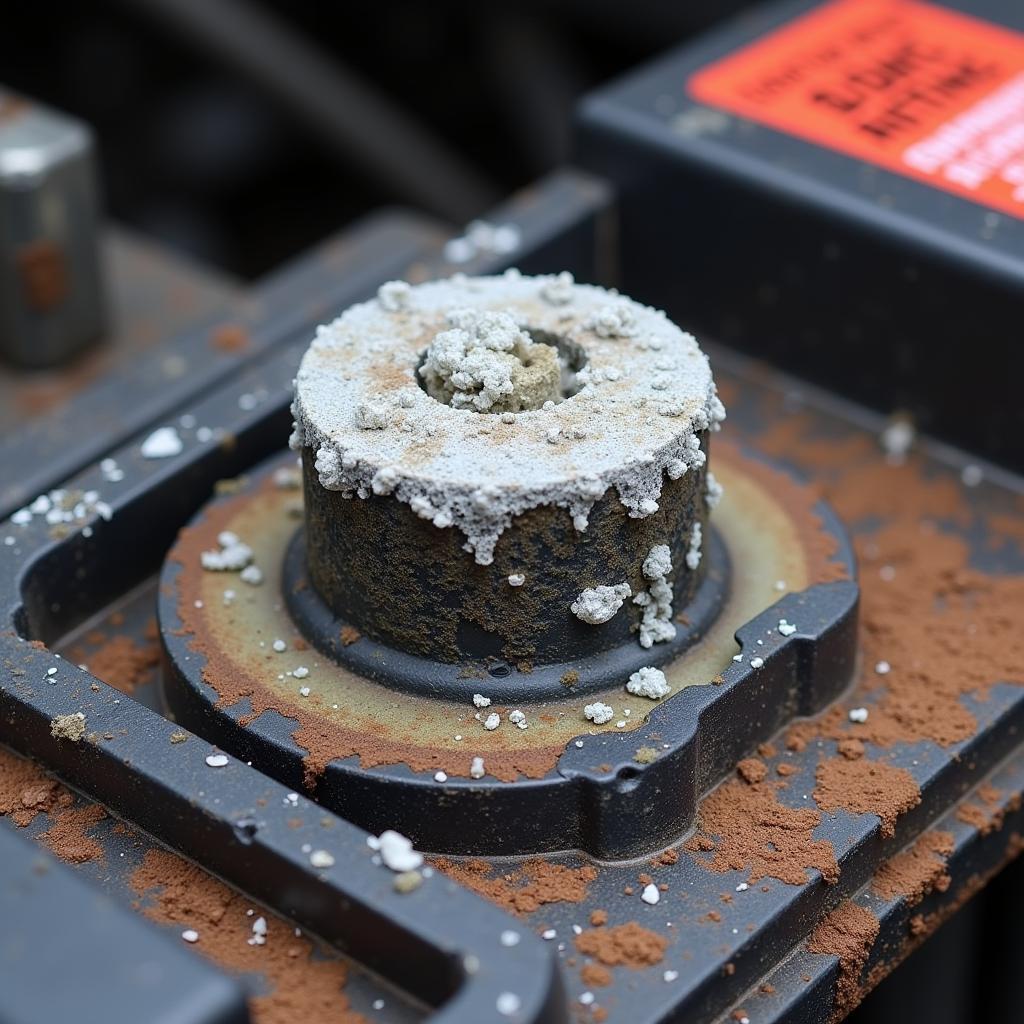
[579, 0, 1024, 468]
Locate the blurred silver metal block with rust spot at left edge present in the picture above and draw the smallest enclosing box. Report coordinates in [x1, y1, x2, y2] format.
[0, 88, 104, 367]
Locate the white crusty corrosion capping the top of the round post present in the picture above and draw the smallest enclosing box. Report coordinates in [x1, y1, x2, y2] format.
[292, 274, 725, 565]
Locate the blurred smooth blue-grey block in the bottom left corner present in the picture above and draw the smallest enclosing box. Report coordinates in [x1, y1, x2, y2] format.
[0, 829, 249, 1024]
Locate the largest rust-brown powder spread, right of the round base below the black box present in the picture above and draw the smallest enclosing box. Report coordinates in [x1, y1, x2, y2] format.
[759, 415, 1024, 750]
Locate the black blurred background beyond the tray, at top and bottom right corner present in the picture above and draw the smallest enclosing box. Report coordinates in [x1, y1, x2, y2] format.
[0, 0, 1024, 1024]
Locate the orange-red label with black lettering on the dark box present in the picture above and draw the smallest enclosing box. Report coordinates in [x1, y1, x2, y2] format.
[688, 0, 1024, 217]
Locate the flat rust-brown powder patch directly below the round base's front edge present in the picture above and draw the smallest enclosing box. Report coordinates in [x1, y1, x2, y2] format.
[434, 857, 597, 914]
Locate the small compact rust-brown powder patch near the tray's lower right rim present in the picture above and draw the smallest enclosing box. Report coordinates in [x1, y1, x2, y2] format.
[814, 757, 921, 836]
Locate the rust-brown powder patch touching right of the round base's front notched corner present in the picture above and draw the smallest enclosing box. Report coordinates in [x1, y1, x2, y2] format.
[687, 765, 839, 885]
